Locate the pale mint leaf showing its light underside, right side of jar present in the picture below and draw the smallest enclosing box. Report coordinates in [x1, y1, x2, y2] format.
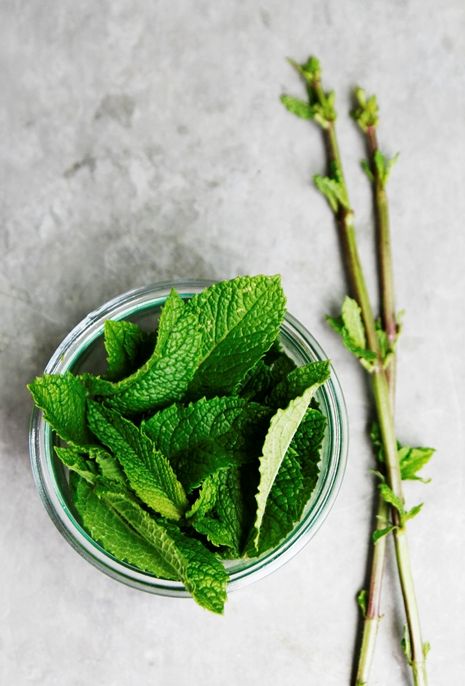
[254, 387, 315, 548]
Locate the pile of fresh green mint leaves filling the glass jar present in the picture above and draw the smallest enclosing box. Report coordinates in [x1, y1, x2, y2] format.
[28, 275, 329, 613]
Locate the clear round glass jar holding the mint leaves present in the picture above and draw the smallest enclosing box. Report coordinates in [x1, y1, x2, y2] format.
[29, 280, 348, 597]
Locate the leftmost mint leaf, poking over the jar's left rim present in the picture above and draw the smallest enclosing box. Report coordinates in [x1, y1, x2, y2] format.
[28, 372, 92, 446]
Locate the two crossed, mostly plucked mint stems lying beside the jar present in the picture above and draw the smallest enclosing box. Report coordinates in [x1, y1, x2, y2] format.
[281, 57, 434, 686]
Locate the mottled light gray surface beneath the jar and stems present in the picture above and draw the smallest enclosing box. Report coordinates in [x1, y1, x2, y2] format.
[0, 0, 465, 686]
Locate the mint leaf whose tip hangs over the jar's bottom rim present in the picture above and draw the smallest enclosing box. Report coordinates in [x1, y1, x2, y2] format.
[99, 488, 228, 614]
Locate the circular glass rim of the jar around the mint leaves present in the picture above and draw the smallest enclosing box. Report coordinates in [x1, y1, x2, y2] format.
[29, 279, 349, 597]
